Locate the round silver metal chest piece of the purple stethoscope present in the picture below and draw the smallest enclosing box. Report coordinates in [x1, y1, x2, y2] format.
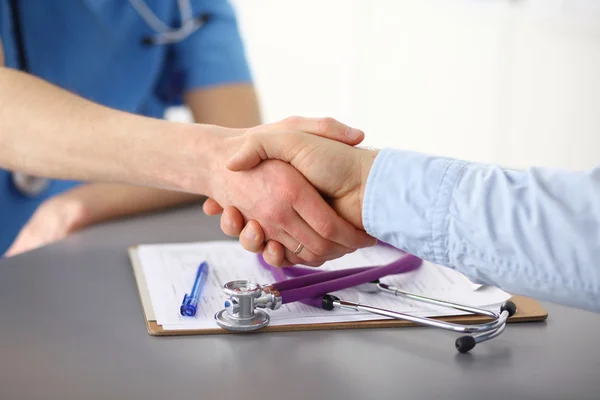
[215, 280, 271, 332]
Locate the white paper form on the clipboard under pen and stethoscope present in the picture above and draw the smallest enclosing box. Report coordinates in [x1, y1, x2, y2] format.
[138, 241, 510, 330]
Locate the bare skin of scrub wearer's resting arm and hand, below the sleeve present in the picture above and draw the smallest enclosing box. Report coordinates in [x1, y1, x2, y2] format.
[6, 84, 260, 256]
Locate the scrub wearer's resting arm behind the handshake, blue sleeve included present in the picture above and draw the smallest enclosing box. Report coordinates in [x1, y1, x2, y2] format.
[6, 1, 260, 255]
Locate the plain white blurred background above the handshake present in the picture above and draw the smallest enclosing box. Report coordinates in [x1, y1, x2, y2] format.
[171, 0, 600, 169]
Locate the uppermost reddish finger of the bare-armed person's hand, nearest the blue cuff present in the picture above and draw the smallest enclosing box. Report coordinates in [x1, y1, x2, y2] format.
[290, 189, 377, 249]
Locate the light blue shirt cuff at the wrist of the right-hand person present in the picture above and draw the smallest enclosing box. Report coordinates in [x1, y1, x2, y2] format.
[362, 149, 468, 264]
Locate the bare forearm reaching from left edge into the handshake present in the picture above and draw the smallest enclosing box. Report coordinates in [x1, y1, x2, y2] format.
[0, 67, 223, 193]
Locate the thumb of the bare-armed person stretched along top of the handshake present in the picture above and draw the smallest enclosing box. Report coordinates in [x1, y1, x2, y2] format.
[274, 117, 365, 146]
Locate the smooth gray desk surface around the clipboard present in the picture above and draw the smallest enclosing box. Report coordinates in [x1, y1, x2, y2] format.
[0, 208, 600, 400]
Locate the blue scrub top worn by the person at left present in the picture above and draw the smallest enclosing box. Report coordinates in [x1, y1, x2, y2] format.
[0, 0, 251, 253]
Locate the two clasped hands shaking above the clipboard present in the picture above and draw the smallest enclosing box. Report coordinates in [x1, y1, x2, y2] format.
[204, 117, 378, 266]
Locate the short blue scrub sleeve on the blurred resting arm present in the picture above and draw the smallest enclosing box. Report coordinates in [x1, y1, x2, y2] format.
[174, 0, 252, 91]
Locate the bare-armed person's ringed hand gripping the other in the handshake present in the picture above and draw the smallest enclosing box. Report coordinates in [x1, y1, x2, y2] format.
[205, 118, 375, 266]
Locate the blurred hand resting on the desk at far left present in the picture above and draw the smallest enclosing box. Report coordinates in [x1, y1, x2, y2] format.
[4, 196, 87, 257]
